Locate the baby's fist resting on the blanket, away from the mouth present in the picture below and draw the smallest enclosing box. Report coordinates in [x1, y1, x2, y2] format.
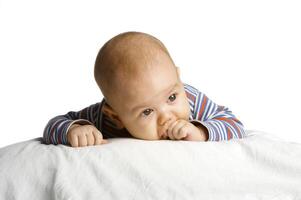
[67, 124, 107, 147]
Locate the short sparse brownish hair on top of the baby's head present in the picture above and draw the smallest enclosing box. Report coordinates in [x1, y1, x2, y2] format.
[94, 32, 173, 104]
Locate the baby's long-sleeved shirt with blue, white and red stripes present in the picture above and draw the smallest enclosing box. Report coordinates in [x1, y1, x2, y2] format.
[43, 84, 245, 145]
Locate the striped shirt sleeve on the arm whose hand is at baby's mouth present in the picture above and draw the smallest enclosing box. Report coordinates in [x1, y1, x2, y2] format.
[191, 87, 245, 141]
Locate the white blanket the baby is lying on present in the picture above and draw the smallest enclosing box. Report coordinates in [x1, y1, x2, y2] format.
[0, 131, 301, 200]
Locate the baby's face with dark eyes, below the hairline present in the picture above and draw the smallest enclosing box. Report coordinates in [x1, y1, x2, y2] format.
[110, 57, 190, 140]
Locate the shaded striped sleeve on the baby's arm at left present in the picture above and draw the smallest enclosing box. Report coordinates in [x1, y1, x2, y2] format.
[43, 101, 104, 145]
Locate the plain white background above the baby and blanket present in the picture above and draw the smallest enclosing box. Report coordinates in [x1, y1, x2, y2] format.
[0, 0, 301, 147]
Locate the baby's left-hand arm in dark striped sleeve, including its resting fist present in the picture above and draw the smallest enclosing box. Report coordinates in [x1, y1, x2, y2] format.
[43, 103, 102, 146]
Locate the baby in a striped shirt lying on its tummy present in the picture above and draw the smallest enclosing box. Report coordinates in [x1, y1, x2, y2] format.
[44, 32, 245, 147]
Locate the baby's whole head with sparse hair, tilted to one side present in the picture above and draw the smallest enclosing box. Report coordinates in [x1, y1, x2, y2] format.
[94, 32, 190, 140]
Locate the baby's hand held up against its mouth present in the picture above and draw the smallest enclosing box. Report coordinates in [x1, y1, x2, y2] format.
[167, 119, 208, 141]
